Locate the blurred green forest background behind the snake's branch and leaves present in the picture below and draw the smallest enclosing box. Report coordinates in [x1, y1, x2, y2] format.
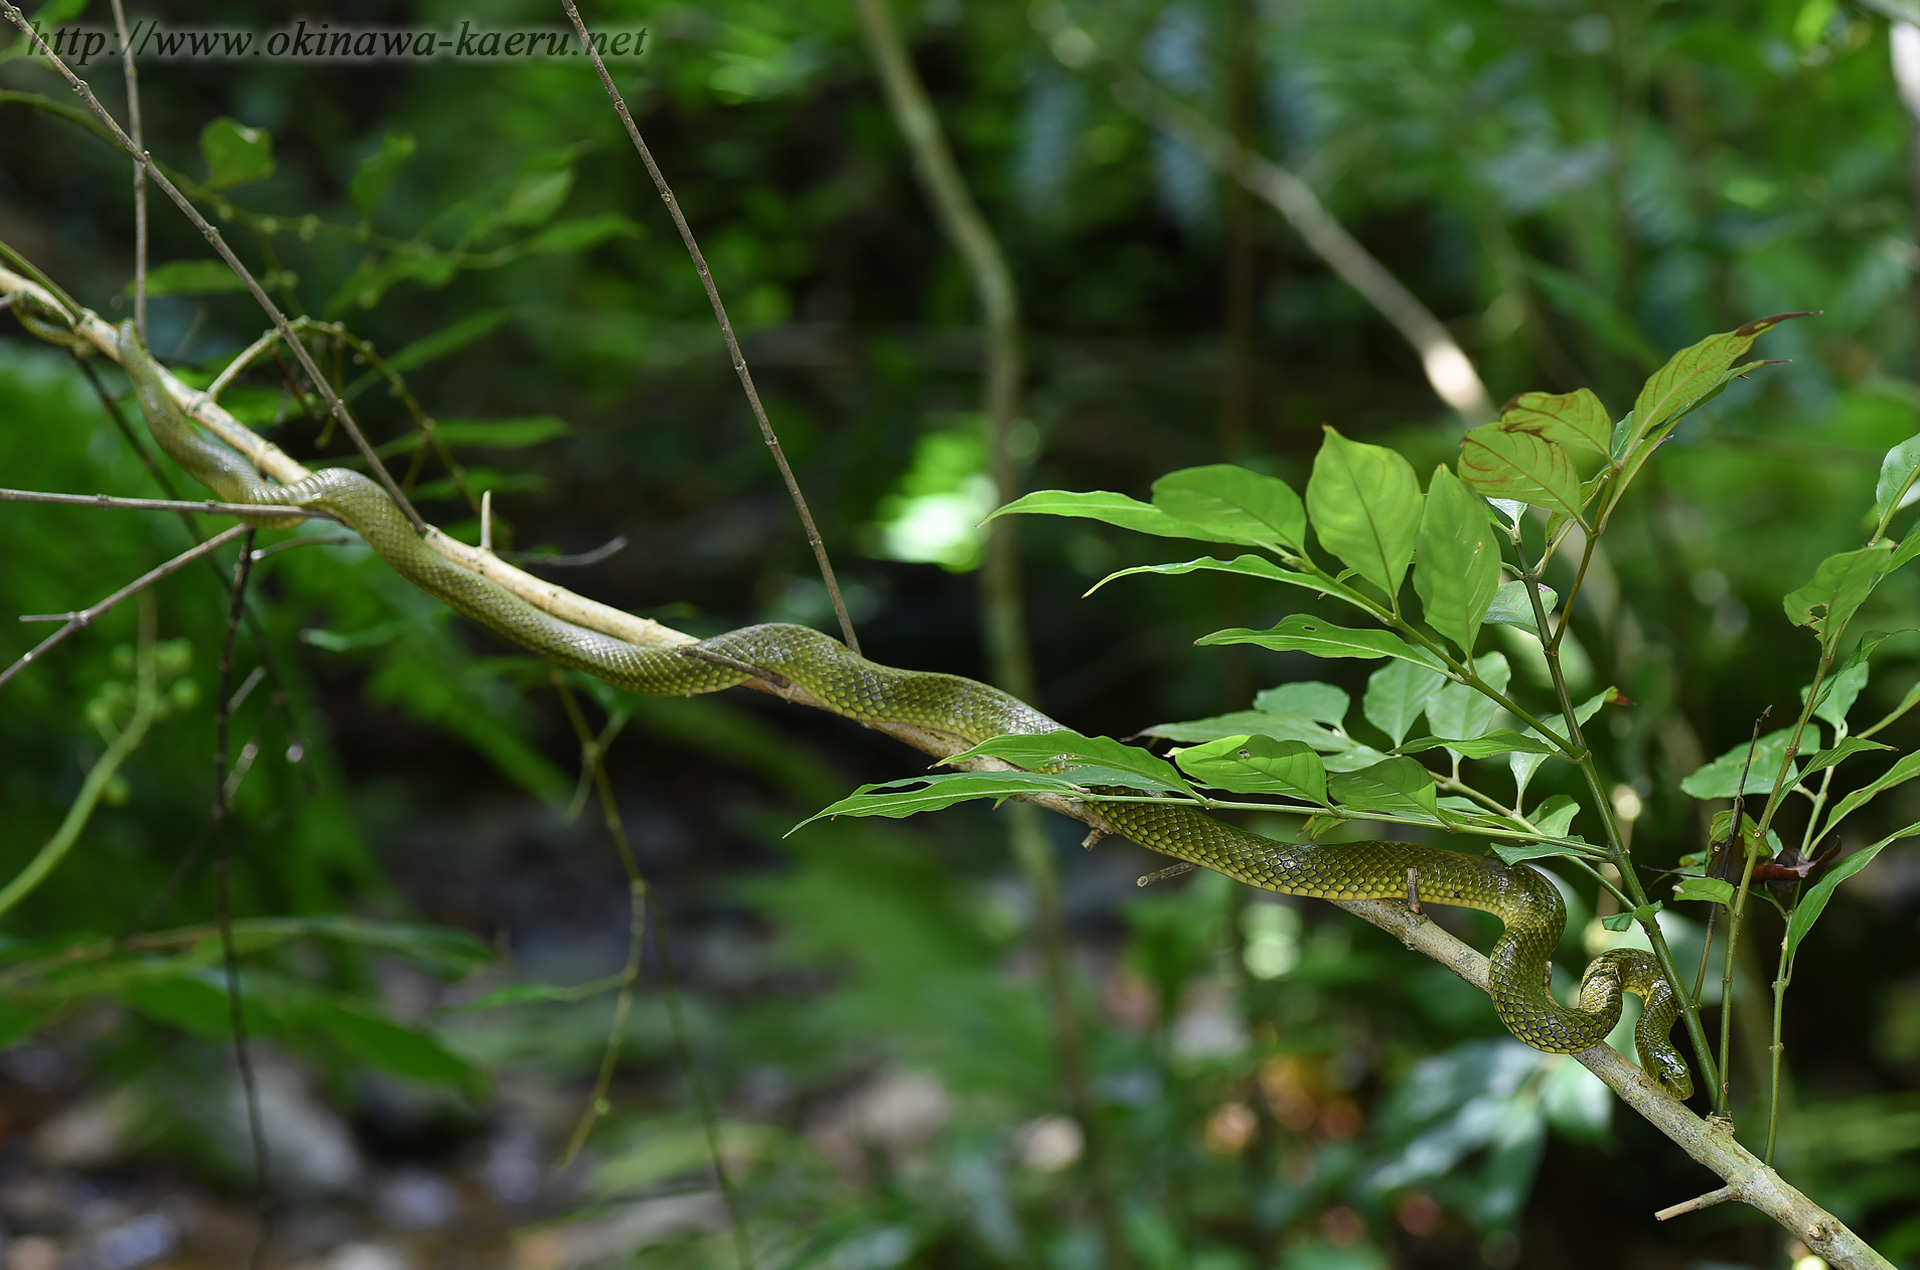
[0, 0, 1920, 1270]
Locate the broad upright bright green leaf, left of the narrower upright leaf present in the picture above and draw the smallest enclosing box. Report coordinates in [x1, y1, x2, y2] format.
[1308, 427, 1421, 599]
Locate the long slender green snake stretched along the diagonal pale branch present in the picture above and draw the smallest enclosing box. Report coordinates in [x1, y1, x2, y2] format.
[119, 323, 1693, 1099]
